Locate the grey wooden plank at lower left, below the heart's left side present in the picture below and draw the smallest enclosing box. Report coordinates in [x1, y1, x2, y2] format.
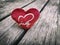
[0, 0, 35, 45]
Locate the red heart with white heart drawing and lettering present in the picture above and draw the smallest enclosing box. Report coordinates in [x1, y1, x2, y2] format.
[11, 8, 40, 30]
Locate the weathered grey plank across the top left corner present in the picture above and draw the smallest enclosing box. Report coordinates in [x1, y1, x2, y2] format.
[0, 0, 36, 20]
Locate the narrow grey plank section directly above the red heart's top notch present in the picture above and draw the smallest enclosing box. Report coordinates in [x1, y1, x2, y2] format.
[24, 0, 47, 11]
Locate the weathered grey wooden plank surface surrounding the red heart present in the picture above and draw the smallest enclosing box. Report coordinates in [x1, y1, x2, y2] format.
[0, 0, 60, 45]
